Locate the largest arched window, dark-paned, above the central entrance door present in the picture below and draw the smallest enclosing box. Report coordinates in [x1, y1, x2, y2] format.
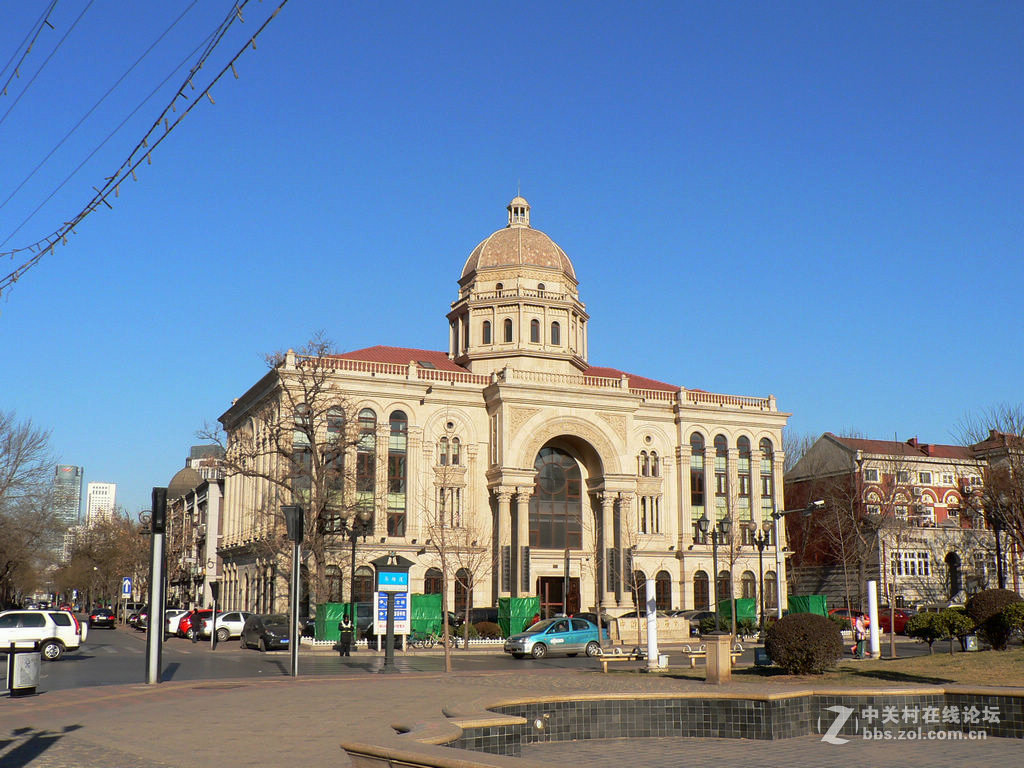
[529, 446, 583, 549]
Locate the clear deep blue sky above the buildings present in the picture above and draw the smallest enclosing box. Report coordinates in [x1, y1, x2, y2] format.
[0, 0, 1024, 512]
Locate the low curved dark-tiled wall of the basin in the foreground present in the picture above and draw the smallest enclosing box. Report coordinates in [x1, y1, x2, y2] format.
[449, 693, 1024, 756]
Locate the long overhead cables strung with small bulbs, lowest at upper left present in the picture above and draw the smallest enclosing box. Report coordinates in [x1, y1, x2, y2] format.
[0, 0, 288, 294]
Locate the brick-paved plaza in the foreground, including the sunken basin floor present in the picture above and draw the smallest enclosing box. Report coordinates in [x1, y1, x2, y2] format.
[0, 665, 1024, 768]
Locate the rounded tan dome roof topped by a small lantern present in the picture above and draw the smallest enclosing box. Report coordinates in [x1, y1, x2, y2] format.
[462, 196, 575, 283]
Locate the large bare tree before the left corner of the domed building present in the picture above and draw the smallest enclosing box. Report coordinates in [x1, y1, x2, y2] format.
[199, 334, 379, 602]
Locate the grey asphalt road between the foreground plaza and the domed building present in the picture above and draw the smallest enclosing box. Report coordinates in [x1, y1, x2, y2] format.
[0, 627, 928, 690]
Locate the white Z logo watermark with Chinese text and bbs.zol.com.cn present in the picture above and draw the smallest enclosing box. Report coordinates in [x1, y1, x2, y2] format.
[818, 705, 999, 744]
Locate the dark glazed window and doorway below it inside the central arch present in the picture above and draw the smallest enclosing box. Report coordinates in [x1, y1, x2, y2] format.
[529, 445, 584, 616]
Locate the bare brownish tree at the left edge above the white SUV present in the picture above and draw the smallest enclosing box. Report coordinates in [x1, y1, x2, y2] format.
[0, 411, 60, 602]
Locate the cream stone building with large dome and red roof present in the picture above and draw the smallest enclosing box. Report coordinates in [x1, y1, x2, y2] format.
[218, 197, 787, 630]
